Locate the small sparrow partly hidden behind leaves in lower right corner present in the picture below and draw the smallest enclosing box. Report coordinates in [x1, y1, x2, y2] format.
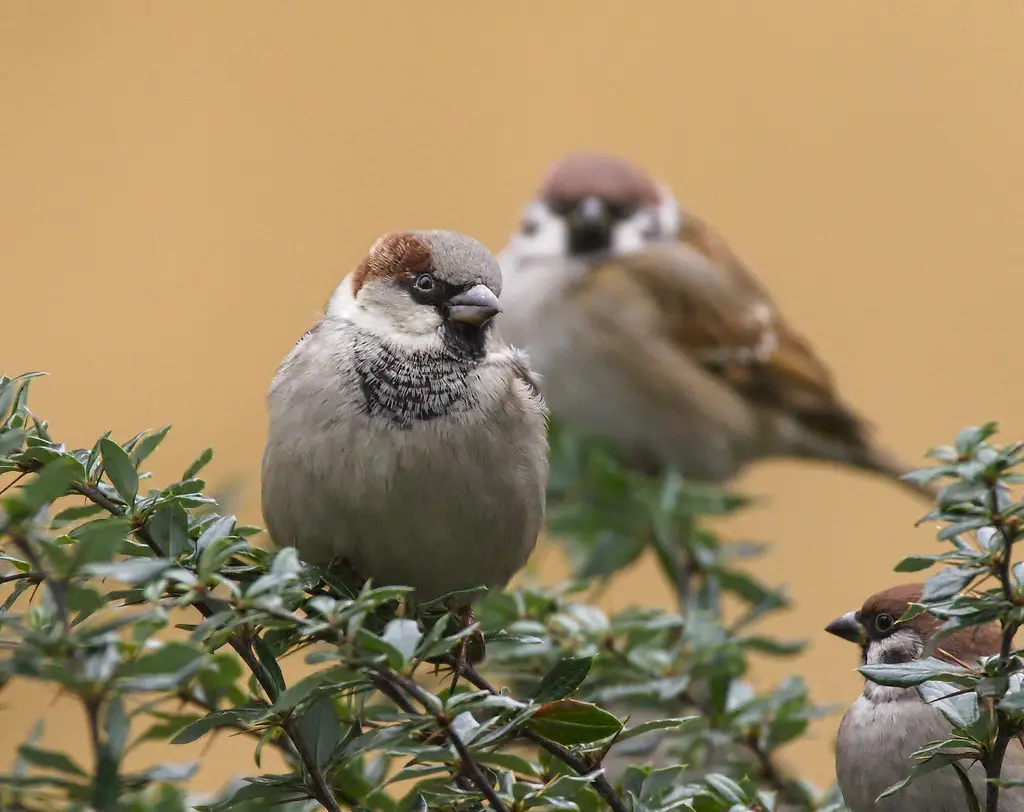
[825, 584, 1024, 812]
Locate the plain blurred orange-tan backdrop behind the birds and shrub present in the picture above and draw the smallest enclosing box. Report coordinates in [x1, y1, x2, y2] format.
[0, 0, 1024, 788]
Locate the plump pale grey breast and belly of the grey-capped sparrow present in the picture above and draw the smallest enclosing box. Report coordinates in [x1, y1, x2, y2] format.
[263, 317, 546, 597]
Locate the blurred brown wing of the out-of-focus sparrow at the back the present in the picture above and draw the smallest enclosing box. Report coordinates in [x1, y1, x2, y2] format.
[616, 218, 867, 446]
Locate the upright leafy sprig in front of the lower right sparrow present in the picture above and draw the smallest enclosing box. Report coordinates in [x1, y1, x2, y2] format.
[860, 423, 1024, 812]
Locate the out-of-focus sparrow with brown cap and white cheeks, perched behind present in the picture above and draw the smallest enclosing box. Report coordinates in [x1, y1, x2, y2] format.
[498, 148, 934, 500]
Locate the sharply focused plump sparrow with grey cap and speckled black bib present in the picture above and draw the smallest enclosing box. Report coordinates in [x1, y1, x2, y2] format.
[262, 230, 548, 606]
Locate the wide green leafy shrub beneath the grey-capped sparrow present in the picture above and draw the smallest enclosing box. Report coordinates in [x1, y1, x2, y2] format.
[0, 376, 839, 812]
